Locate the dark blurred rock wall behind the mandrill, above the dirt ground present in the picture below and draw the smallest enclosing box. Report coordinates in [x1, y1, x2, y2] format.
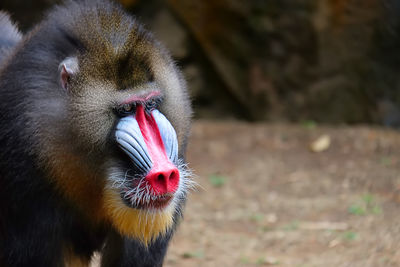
[0, 0, 400, 126]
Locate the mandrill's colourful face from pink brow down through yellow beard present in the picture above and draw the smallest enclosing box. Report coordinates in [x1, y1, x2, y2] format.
[99, 87, 191, 246]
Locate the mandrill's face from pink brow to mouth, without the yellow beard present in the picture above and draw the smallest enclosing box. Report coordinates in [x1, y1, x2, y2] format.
[115, 95, 182, 210]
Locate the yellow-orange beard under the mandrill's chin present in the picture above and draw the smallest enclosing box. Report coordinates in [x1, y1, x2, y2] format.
[104, 187, 175, 245]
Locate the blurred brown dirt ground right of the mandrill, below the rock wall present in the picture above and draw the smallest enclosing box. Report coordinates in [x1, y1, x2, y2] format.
[165, 121, 400, 267]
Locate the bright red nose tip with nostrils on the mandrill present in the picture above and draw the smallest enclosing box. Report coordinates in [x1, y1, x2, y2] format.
[146, 162, 179, 195]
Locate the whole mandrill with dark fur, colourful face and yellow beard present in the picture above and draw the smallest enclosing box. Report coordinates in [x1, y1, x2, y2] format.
[0, 0, 191, 266]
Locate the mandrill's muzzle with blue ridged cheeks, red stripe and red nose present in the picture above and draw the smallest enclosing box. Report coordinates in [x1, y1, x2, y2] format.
[115, 105, 179, 195]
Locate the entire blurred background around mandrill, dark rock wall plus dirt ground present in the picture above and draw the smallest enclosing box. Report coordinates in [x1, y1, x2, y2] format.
[0, 0, 400, 267]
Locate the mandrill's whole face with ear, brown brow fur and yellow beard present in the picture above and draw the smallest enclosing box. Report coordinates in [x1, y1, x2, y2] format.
[44, 24, 192, 246]
